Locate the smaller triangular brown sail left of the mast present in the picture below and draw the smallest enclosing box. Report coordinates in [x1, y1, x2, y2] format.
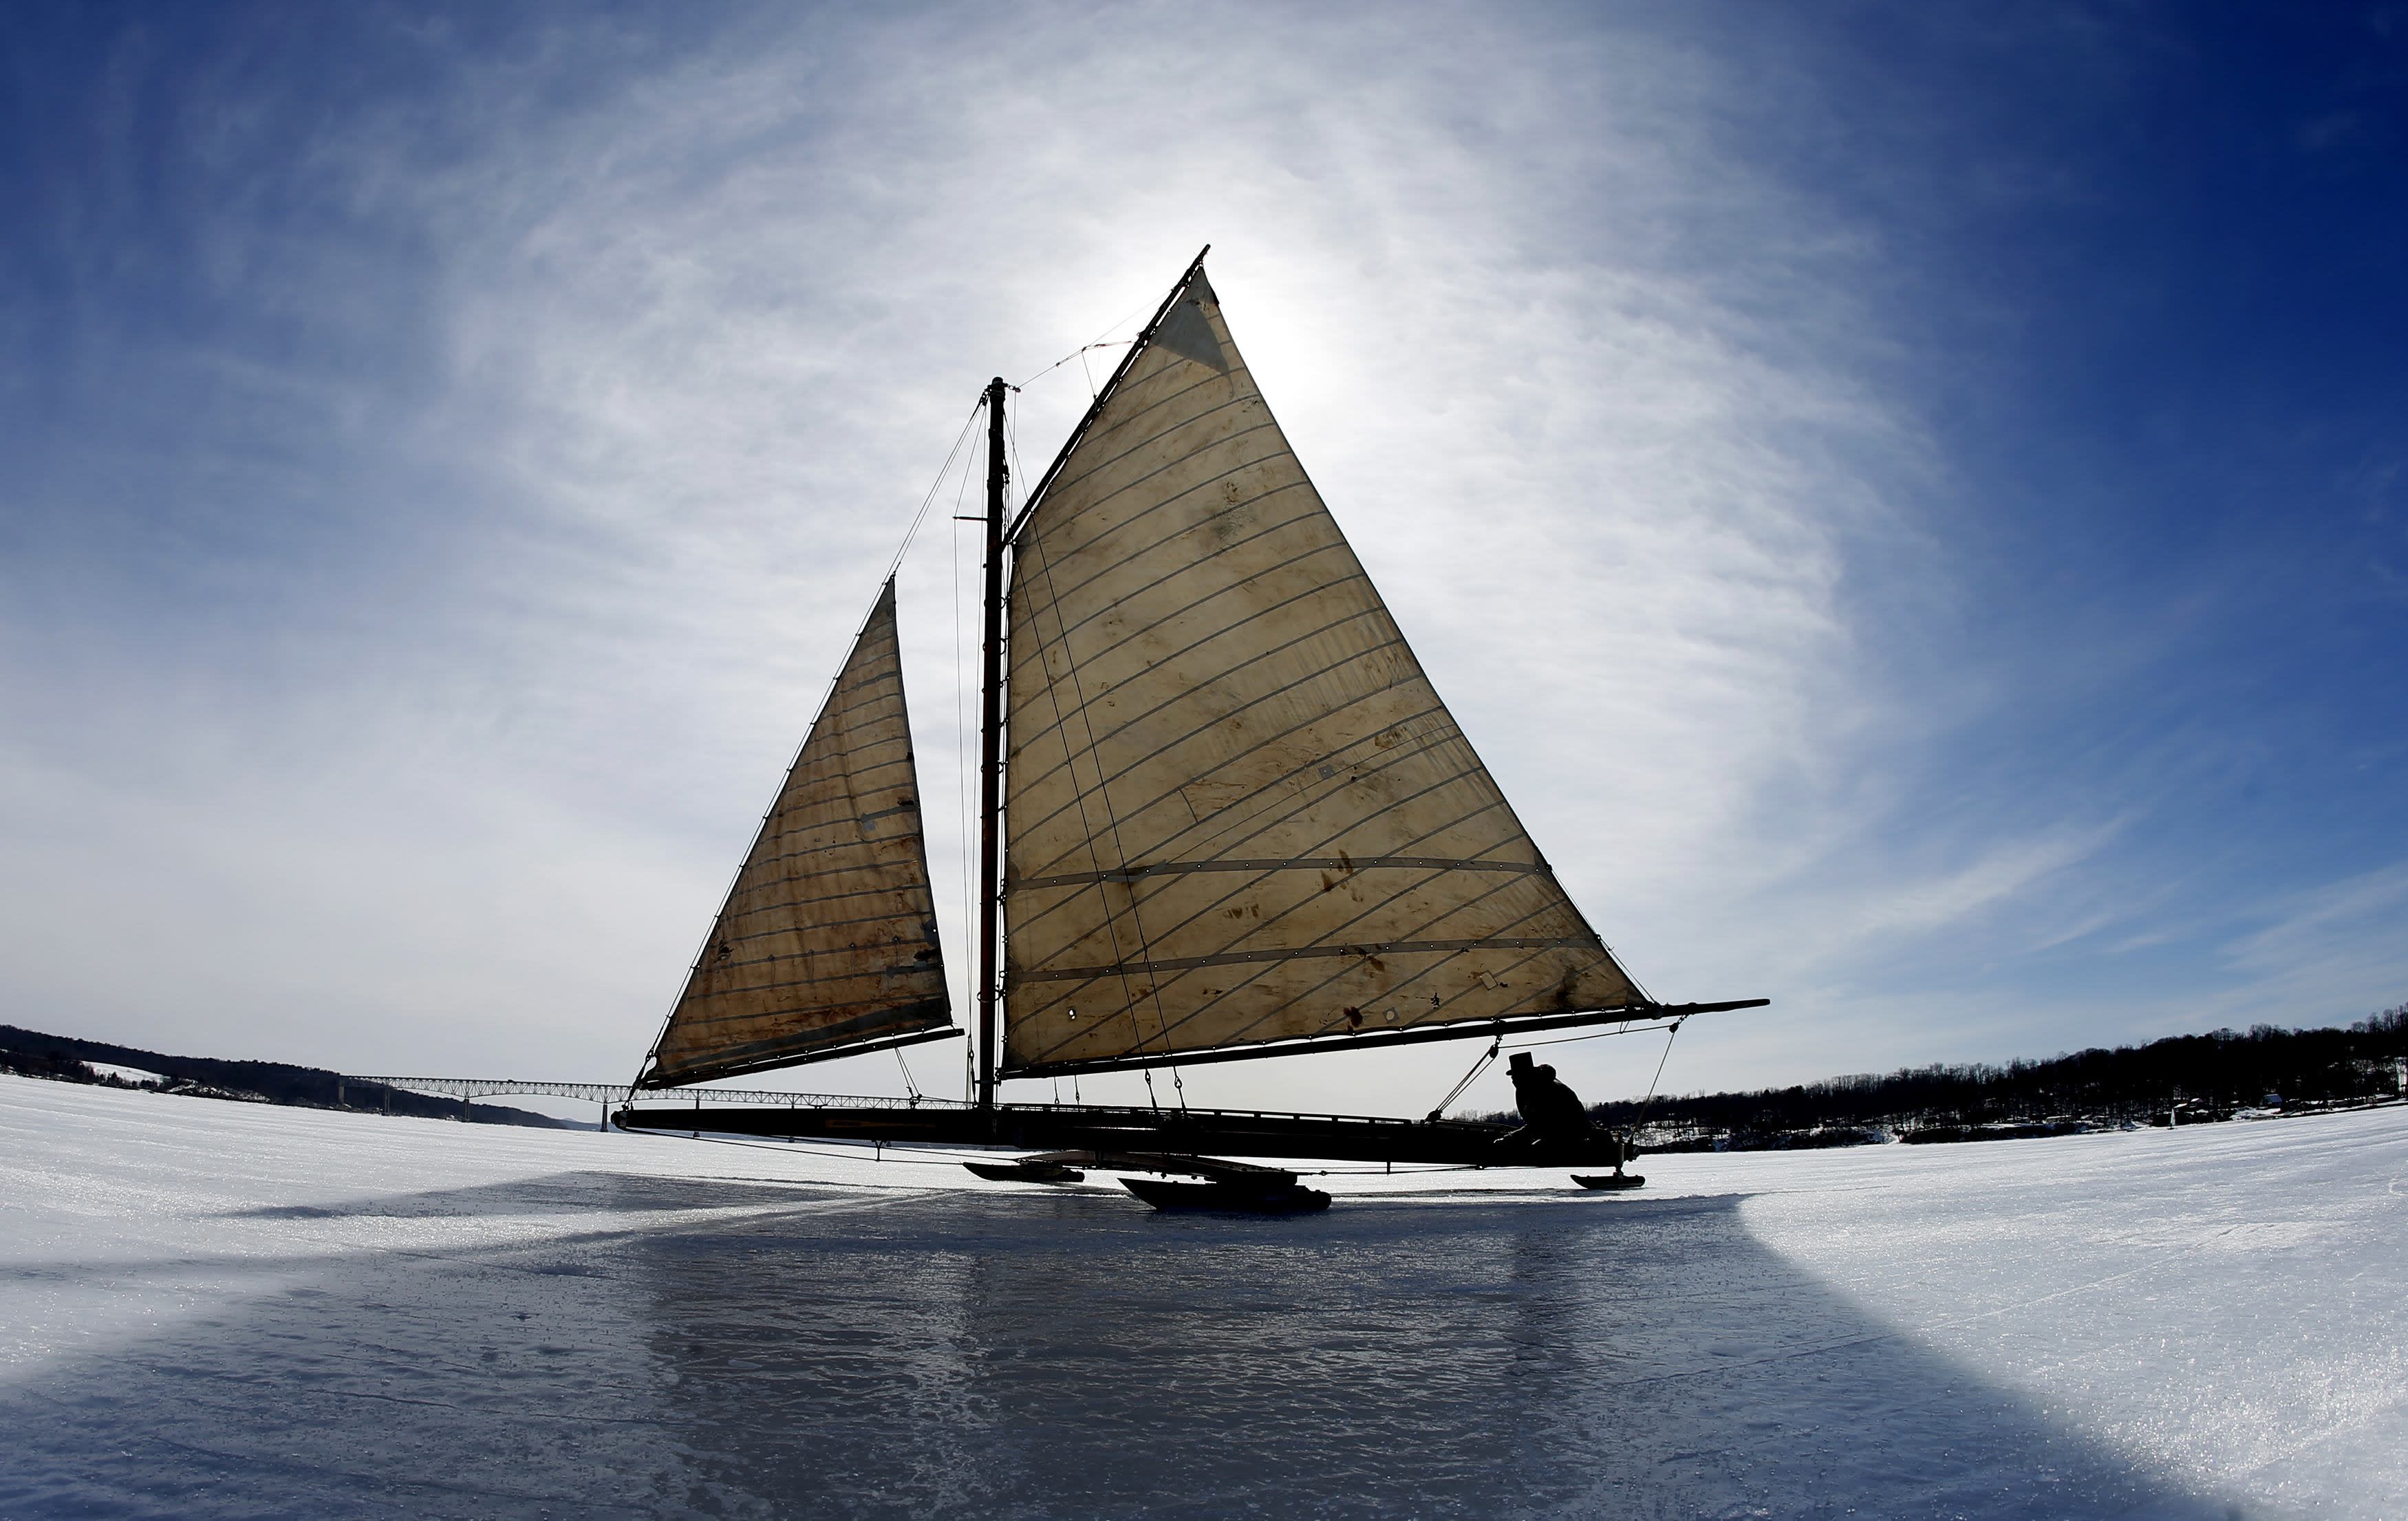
[638, 580, 954, 1088]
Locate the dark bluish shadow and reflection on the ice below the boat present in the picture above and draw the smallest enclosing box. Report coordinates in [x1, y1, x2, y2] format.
[0, 1174, 2208, 1516]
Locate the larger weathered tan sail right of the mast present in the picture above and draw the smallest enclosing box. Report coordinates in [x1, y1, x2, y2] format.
[1002, 270, 1645, 1076]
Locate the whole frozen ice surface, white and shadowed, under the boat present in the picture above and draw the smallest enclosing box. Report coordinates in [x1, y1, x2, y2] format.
[0, 1078, 2408, 1519]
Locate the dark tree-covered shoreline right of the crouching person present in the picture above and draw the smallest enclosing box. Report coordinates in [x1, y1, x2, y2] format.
[1560, 1004, 2408, 1150]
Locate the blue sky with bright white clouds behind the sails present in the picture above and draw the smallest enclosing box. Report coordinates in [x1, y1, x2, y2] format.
[0, 0, 2408, 1112]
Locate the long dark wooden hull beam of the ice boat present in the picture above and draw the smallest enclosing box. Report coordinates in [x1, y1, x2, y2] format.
[614, 1105, 1626, 1167]
